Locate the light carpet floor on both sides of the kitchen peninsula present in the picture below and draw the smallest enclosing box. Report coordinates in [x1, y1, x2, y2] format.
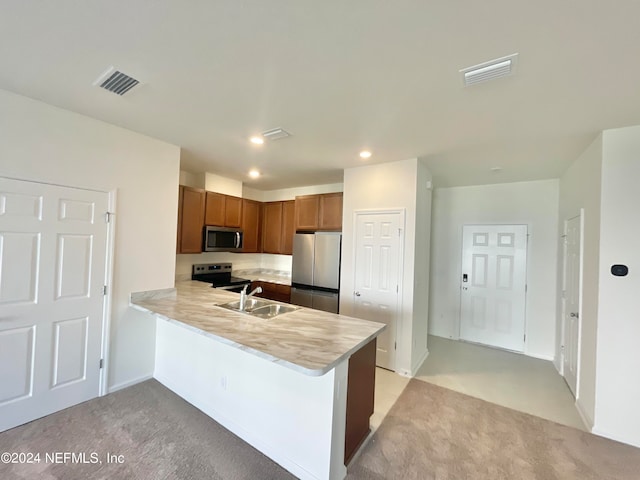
[0, 380, 640, 480]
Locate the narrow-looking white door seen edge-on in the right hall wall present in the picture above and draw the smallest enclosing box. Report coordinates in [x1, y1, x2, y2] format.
[562, 216, 581, 397]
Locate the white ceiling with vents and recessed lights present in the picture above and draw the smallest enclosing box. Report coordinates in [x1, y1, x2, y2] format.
[0, 0, 640, 190]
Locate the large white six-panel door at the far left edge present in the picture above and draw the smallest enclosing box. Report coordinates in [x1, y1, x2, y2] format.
[0, 177, 108, 431]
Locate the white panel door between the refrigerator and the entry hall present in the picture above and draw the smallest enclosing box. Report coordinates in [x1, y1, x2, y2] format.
[353, 212, 403, 370]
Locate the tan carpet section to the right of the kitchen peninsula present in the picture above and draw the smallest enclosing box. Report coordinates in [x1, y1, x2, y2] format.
[348, 379, 640, 480]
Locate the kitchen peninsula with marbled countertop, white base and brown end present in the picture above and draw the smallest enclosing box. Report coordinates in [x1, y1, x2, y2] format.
[131, 281, 385, 480]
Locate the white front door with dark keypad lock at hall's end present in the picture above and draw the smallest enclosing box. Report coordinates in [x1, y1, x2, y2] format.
[460, 225, 527, 352]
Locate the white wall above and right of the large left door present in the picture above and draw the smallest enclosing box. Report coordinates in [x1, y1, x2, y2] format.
[0, 90, 180, 388]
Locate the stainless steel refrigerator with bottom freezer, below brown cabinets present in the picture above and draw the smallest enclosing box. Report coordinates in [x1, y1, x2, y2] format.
[291, 232, 342, 313]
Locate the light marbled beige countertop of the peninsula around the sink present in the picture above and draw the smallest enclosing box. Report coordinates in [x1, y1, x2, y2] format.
[131, 281, 386, 376]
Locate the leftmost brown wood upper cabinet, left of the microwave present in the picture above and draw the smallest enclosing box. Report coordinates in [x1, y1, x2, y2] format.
[177, 185, 205, 253]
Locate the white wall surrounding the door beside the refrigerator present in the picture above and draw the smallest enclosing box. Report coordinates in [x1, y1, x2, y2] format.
[340, 158, 426, 375]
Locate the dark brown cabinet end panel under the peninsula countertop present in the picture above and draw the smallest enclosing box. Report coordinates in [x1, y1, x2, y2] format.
[344, 339, 376, 465]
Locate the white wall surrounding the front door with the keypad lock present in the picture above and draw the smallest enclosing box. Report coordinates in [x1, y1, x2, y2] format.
[429, 180, 559, 360]
